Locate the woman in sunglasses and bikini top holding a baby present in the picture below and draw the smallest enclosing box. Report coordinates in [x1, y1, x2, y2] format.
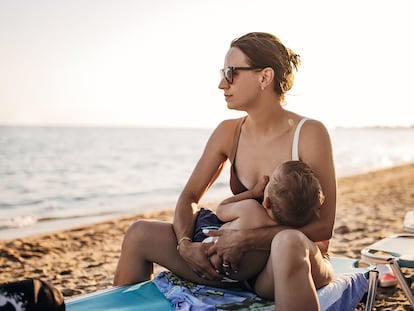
[114, 33, 336, 310]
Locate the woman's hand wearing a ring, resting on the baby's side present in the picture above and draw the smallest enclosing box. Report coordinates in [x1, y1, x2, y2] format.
[203, 229, 245, 274]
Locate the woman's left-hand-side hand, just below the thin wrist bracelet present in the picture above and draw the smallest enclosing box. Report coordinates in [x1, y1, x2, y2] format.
[179, 241, 223, 281]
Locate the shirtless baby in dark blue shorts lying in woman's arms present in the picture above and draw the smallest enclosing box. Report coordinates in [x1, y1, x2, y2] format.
[193, 161, 325, 278]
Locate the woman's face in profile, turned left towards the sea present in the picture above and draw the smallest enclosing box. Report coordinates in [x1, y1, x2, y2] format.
[218, 47, 261, 111]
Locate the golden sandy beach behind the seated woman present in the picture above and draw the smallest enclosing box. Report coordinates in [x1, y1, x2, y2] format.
[0, 164, 414, 310]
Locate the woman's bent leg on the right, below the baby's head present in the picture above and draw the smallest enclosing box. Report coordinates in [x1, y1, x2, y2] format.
[255, 230, 333, 311]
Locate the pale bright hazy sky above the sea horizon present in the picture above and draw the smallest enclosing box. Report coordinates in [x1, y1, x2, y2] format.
[0, 0, 414, 128]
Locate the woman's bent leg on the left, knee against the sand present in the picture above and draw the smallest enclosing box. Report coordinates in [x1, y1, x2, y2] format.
[113, 220, 225, 285]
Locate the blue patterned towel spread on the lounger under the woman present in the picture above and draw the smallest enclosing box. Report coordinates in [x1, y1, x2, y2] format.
[153, 271, 368, 311]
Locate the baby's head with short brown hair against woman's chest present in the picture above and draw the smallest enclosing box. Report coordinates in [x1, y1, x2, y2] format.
[264, 161, 325, 227]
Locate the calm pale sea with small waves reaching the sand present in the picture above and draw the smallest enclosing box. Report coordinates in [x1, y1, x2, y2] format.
[0, 126, 414, 240]
